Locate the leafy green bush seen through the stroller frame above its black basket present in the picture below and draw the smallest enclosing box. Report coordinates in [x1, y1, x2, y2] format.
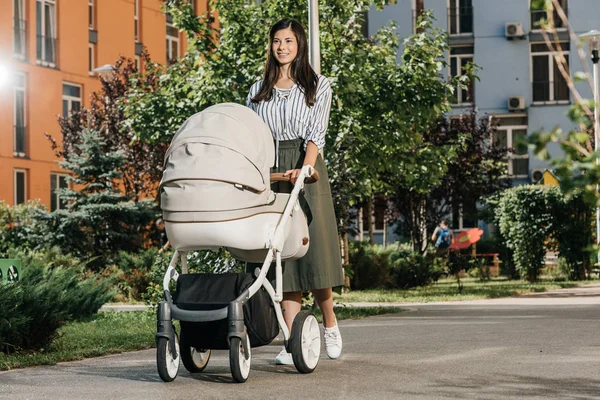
[142, 248, 245, 305]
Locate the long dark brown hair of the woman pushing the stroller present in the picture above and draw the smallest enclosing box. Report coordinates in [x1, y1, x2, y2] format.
[252, 18, 319, 106]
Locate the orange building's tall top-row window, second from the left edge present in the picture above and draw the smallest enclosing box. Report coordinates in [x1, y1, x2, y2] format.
[35, 0, 56, 67]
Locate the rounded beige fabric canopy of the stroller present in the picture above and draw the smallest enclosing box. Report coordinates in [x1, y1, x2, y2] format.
[160, 103, 275, 216]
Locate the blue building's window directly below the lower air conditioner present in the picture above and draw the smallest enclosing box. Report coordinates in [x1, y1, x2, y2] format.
[494, 125, 529, 178]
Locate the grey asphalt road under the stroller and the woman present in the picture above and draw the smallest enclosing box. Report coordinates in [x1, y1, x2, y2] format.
[0, 287, 600, 400]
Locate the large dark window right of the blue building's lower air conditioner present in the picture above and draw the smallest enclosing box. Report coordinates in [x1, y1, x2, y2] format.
[531, 42, 569, 104]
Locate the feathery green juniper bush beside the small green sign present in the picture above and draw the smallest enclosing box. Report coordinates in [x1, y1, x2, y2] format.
[0, 249, 112, 353]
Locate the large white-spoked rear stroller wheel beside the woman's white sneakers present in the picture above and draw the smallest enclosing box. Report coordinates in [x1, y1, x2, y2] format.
[290, 311, 321, 374]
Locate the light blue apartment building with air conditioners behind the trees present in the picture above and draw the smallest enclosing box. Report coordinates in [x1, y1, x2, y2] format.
[360, 0, 600, 241]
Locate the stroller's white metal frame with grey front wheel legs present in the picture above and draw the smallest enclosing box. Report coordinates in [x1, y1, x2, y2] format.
[156, 165, 320, 382]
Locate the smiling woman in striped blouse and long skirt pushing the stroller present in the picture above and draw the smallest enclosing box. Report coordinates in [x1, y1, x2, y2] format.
[246, 19, 344, 365]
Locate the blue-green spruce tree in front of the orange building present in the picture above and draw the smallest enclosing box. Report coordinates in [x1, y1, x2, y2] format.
[30, 128, 157, 267]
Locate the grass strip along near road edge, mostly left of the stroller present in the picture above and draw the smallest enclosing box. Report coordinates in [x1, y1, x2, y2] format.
[0, 307, 402, 371]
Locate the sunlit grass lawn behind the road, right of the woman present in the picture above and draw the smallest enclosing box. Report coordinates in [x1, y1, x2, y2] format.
[334, 278, 598, 304]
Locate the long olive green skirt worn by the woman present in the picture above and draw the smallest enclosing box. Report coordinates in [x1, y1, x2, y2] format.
[250, 139, 344, 292]
